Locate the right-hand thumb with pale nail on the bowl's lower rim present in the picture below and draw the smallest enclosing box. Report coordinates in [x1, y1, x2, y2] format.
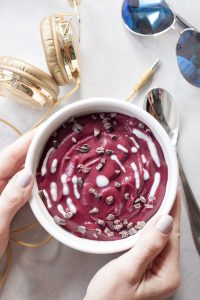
[119, 215, 173, 278]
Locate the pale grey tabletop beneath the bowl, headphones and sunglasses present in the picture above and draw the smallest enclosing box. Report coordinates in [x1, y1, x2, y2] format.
[0, 0, 200, 300]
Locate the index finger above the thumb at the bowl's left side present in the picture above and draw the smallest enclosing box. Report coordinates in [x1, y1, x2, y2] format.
[0, 130, 35, 193]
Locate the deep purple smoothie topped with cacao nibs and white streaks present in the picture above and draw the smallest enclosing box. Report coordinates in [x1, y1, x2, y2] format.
[36, 113, 168, 240]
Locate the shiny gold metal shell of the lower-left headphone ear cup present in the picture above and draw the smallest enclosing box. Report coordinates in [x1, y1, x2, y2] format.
[0, 68, 55, 108]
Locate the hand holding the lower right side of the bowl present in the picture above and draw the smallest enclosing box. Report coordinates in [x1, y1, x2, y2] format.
[84, 191, 180, 300]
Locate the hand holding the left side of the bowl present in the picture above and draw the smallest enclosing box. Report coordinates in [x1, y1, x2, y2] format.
[0, 131, 34, 258]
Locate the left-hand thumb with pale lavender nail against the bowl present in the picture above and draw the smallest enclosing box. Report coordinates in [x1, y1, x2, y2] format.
[0, 170, 33, 239]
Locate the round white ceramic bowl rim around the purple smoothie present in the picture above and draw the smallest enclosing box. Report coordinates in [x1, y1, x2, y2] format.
[26, 98, 178, 254]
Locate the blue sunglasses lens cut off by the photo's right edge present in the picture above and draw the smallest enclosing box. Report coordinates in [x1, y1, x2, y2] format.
[176, 29, 200, 87]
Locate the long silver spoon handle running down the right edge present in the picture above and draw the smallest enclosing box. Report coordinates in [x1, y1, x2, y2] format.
[177, 154, 200, 255]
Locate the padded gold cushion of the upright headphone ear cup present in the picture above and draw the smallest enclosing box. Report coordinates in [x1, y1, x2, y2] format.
[40, 15, 69, 85]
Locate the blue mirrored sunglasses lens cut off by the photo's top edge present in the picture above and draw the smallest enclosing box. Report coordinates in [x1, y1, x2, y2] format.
[122, 0, 174, 35]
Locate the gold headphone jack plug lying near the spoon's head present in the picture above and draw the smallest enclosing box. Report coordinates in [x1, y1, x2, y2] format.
[126, 59, 160, 101]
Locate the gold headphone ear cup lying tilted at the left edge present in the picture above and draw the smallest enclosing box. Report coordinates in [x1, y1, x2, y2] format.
[0, 56, 59, 107]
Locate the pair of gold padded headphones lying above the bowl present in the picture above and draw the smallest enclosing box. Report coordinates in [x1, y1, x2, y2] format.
[0, 0, 80, 108]
